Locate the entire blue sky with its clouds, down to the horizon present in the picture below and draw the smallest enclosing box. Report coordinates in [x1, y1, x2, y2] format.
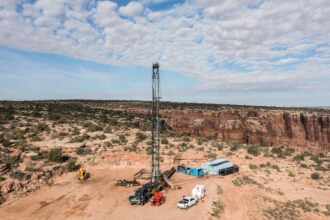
[0, 0, 330, 106]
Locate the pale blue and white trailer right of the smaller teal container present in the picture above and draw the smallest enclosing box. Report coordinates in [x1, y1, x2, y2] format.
[202, 158, 239, 176]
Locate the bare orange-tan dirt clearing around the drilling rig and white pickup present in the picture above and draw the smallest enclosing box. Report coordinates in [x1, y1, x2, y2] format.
[0, 159, 329, 220]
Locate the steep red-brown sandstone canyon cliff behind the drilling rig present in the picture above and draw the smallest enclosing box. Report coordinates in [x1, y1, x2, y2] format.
[128, 108, 330, 153]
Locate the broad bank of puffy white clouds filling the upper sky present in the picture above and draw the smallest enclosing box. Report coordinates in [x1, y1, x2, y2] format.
[0, 0, 330, 93]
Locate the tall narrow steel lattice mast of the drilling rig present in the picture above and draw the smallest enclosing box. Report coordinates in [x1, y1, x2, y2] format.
[151, 63, 160, 183]
